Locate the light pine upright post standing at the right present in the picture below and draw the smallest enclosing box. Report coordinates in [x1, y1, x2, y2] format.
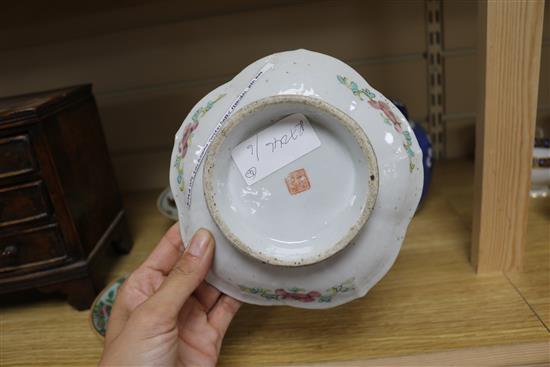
[471, 0, 544, 272]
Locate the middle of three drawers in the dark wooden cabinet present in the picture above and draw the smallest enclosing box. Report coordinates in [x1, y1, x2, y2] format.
[0, 181, 50, 228]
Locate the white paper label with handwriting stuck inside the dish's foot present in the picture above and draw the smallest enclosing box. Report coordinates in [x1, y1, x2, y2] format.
[231, 113, 321, 185]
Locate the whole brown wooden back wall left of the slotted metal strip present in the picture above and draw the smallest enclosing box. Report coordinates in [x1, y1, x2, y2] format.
[0, 0, 426, 190]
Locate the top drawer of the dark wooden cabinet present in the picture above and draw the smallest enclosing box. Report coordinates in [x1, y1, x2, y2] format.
[0, 134, 36, 178]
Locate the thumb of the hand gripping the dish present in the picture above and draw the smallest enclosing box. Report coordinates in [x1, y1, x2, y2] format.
[150, 228, 215, 318]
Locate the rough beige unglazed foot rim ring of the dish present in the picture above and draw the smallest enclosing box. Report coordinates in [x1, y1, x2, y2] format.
[203, 95, 379, 267]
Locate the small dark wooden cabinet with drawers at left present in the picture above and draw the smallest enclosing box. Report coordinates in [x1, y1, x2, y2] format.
[0, 85, 131, 309]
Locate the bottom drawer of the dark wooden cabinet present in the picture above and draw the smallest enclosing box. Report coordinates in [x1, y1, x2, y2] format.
[0, 224, 66, 274]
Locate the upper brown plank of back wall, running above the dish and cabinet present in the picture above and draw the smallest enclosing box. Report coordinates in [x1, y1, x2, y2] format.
[0, 1, 425, 95]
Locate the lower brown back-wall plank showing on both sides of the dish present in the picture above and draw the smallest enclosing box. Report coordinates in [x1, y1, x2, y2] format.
[102, 59, 432, 191]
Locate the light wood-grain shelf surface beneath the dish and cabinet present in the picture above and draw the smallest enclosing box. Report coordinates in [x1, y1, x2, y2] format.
[0, 161, 550, 366]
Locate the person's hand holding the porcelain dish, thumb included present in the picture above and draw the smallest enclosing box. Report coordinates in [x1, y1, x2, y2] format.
[100, 223, 240, 366]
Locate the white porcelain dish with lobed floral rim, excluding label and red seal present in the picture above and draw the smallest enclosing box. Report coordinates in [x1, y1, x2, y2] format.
[170, 50, 423, 308]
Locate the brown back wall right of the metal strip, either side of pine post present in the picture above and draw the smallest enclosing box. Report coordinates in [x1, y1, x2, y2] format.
[443, 0, 550, 158]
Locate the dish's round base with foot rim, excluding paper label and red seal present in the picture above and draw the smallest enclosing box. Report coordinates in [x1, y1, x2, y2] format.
[203, 95, 378, 266]
